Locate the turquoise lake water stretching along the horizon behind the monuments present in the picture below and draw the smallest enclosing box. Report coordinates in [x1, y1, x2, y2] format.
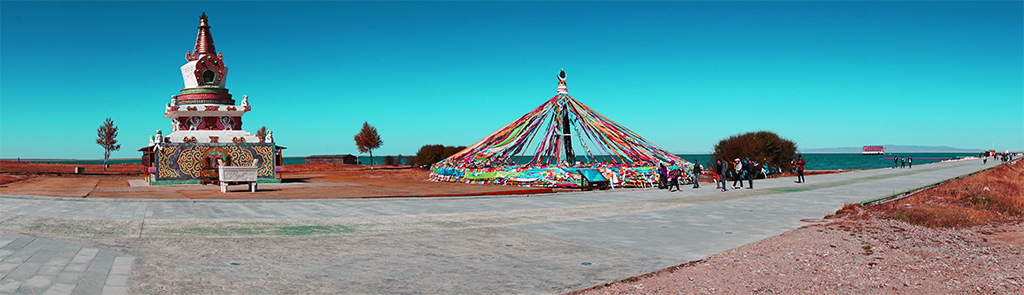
[12, 153, 978, 170]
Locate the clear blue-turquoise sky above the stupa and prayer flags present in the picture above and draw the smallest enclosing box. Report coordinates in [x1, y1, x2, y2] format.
[0, 1, 1024, 159]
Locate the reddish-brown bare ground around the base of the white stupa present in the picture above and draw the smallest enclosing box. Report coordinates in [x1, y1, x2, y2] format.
[0, 161, 552, 200]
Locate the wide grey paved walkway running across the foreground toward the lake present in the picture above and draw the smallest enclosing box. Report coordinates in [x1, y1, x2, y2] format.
[0, 160, 996, 294]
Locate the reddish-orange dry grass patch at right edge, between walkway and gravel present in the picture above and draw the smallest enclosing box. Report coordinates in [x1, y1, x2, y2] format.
[851, 161, 1024, 227]
